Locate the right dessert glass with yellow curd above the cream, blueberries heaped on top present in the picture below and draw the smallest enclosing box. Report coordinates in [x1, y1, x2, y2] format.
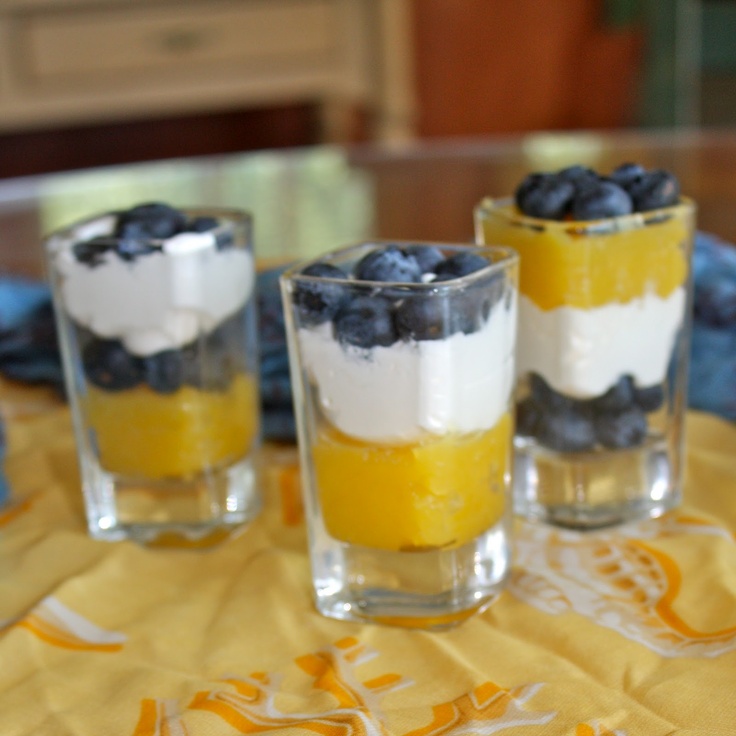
[475, 164, 695, 528]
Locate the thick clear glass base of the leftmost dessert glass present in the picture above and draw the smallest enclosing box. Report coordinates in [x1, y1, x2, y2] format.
[82, 457, 261, 547]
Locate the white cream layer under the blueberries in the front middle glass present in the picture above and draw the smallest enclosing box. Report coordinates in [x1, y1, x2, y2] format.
[299, 300, 516, 444]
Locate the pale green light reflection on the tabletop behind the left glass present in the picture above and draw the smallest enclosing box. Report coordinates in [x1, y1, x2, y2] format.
[40, 146, 374, 262]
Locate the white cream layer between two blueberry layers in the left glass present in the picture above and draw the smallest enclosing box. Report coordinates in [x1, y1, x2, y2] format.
[54, 217, 255, 356]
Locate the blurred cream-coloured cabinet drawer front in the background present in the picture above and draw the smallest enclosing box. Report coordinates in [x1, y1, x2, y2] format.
[15, 0, 337, 83]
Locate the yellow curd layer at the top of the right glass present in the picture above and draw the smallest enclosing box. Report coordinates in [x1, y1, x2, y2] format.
[480, 204, 692, 310]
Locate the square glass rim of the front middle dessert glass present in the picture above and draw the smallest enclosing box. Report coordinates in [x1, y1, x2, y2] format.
[280, 238, 519, 291]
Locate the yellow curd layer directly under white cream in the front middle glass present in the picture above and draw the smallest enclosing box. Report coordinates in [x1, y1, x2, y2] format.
[313, 414, 511, 551]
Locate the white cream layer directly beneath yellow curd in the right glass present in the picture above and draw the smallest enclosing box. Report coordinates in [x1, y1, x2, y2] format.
[517, 287, 686, 399]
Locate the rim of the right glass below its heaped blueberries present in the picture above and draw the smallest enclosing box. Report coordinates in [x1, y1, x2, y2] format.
[474, 196, 697, 234]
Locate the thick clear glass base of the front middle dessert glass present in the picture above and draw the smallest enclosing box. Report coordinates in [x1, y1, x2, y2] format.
[312, 520, 511, 630]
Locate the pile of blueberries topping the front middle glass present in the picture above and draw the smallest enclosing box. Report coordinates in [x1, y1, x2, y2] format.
[294, 244, 500, 349]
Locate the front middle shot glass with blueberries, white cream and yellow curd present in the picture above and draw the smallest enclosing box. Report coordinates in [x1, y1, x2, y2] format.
[281, 242, 518, 629]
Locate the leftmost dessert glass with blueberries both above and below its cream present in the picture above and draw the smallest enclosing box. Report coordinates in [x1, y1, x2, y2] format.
[45, 203, 260, 546]
